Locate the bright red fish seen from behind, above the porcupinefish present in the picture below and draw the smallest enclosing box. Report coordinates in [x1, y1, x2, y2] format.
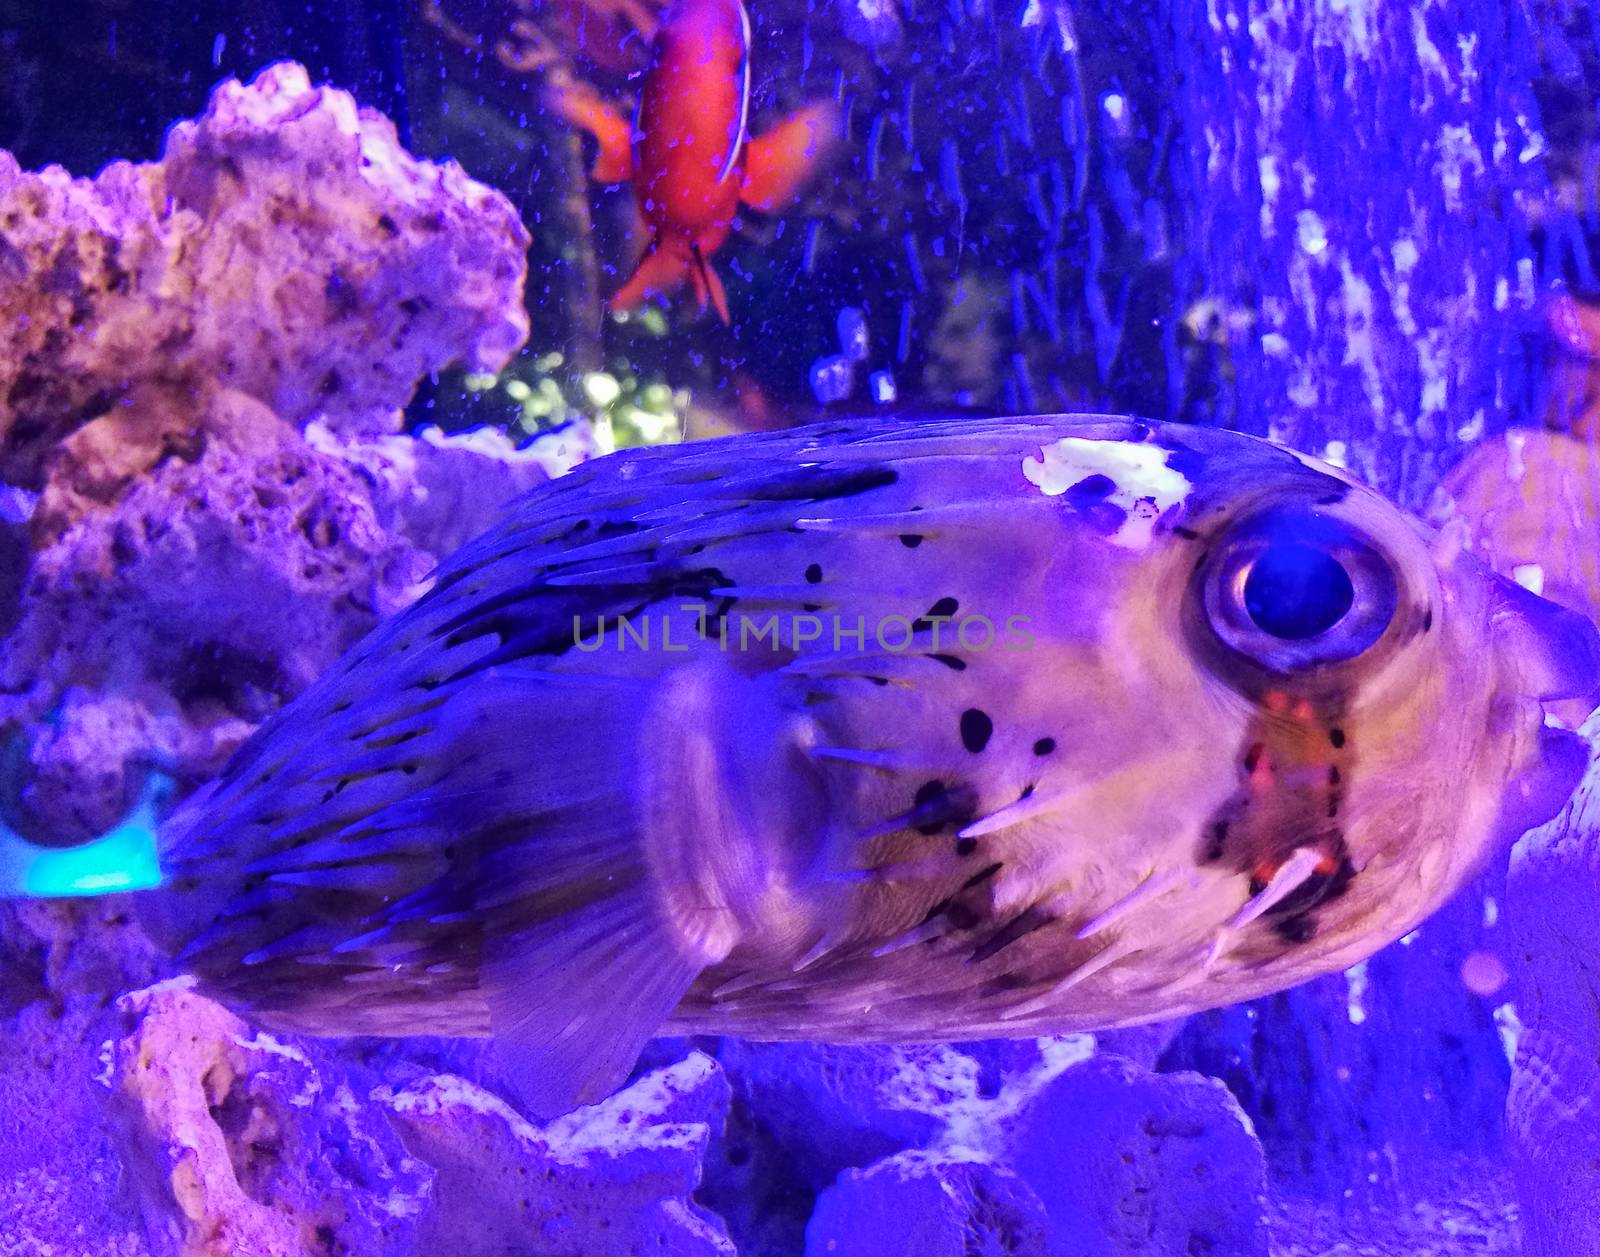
[552, 0, 838, 323]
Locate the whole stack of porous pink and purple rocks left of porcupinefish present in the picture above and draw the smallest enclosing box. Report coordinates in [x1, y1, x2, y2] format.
[0, 62, 547, 844]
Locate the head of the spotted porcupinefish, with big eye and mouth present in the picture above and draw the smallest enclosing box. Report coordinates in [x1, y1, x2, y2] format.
[998, 429, 1600, 972]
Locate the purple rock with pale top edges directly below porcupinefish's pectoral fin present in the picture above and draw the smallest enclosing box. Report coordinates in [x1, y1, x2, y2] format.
[380, 1054, 734, 1257]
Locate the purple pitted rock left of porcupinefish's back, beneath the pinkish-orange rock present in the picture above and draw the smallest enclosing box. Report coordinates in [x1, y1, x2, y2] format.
[0, 393, 432, 843]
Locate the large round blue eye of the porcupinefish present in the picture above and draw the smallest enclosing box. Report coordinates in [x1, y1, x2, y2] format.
[1198, 510, 1398, 673]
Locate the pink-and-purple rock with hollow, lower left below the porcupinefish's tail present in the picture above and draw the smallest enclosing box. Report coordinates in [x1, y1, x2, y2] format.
[112, 984, 443, 1257]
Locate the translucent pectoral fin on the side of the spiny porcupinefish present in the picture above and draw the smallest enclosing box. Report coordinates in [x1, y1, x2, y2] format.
[480, 660, 818, 1118]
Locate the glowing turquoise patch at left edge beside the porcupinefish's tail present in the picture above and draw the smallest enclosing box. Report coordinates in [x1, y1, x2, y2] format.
[0, 782, 166, 899]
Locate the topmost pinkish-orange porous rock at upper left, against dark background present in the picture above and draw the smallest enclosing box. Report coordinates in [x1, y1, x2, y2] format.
[0, 64, 528, 488]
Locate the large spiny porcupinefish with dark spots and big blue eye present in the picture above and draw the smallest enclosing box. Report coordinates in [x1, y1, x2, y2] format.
[144, 416, 1600, 1115]
